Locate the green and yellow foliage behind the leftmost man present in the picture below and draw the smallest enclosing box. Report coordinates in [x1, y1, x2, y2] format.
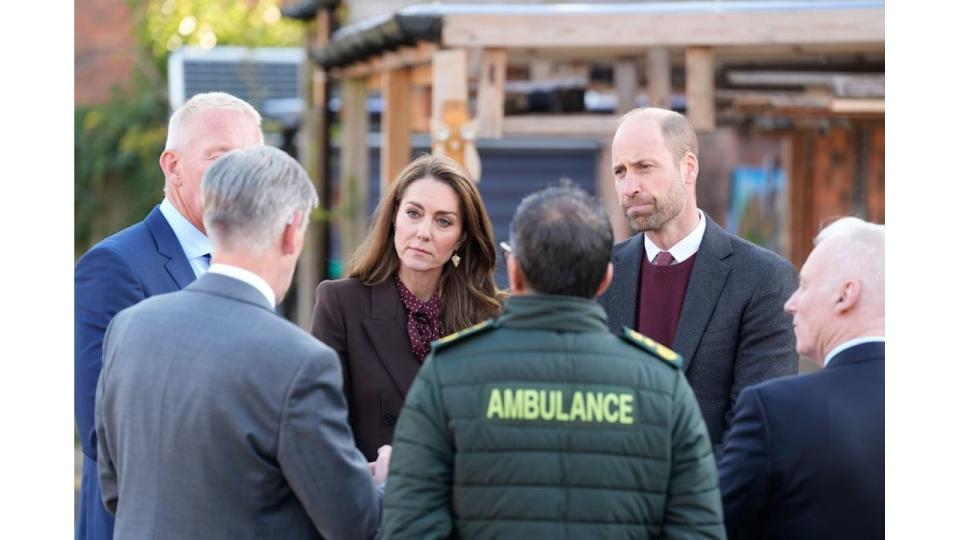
[74, 0, 303, 255]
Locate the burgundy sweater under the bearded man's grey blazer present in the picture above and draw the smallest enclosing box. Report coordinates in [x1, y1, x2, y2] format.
[637, 253, 697, 347]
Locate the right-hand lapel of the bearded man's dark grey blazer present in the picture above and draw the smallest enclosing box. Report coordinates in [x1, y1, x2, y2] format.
[673, 214, 733, 373]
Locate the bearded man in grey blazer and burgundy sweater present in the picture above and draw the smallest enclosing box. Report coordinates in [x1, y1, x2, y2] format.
[599, 108, 797, 457]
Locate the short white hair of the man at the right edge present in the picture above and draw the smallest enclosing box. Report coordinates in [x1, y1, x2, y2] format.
[813, 217, 886, 305]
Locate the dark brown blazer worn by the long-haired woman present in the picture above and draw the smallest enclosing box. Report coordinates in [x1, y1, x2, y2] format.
[311, 278, 420, 461]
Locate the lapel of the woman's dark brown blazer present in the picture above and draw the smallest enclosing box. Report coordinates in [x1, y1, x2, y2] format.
[362, 280, 420, 397]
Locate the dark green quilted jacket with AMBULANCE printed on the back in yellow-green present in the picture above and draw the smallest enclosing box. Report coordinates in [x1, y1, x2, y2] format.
[382, 295, 725, 540]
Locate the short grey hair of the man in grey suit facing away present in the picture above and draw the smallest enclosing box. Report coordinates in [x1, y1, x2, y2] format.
[200, 146, 319, 253]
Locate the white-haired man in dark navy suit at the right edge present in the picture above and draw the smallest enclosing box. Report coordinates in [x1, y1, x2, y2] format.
[720, 218, 885, 539]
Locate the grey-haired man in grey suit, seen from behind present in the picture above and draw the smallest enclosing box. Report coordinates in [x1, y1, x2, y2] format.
[95, 147, 385, 540]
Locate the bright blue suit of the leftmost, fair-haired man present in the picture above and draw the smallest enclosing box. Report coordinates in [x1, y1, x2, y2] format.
[73, 207, 196, 540]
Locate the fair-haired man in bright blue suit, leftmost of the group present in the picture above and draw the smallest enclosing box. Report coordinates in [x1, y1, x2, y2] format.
[74, 92, 263, 540]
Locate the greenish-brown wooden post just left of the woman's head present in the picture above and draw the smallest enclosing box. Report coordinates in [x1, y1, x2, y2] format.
[337, 78, 370, 266]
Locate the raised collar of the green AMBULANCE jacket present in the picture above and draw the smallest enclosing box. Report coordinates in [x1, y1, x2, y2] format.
[499, 294, 608, 332]
